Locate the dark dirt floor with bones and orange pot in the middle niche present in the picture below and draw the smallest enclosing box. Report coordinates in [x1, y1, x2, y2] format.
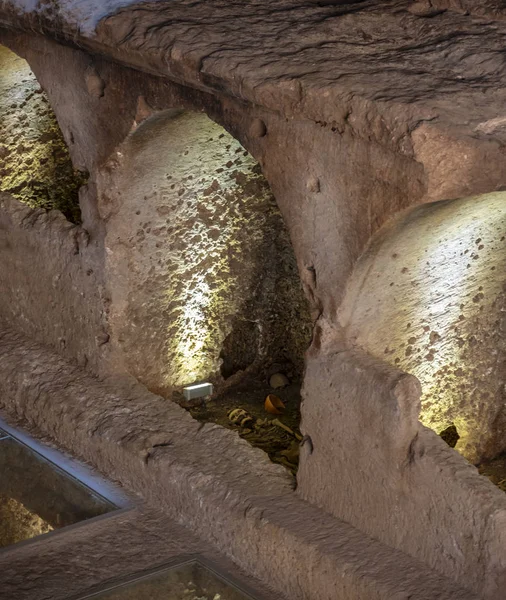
[183, 381, 302, 475]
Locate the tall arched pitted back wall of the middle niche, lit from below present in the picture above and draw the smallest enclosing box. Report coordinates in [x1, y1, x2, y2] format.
[97, 110, 311, 395]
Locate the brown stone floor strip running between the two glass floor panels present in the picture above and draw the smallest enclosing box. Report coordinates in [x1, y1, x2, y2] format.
[0, 504, 285, 600]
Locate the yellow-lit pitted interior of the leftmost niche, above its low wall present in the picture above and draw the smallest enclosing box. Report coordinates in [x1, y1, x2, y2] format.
[0, 46, 85, 223]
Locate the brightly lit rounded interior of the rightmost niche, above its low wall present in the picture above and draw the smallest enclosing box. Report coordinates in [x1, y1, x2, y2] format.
[340, 192, 506, 488]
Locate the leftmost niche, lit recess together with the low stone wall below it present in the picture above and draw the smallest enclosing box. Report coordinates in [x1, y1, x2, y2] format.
[0, 46, 106, 372]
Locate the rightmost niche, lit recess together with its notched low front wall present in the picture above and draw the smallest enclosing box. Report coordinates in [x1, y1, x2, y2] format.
[297, 197, 506, 600]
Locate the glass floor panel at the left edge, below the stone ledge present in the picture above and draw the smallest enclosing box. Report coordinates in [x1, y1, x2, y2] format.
[0, 422, 117, 548]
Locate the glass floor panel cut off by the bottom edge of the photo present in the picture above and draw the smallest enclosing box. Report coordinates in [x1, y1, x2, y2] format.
[81, 560, 264, 600]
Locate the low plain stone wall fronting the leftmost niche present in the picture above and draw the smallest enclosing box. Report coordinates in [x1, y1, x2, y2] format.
[0, 193, 106, 370]
